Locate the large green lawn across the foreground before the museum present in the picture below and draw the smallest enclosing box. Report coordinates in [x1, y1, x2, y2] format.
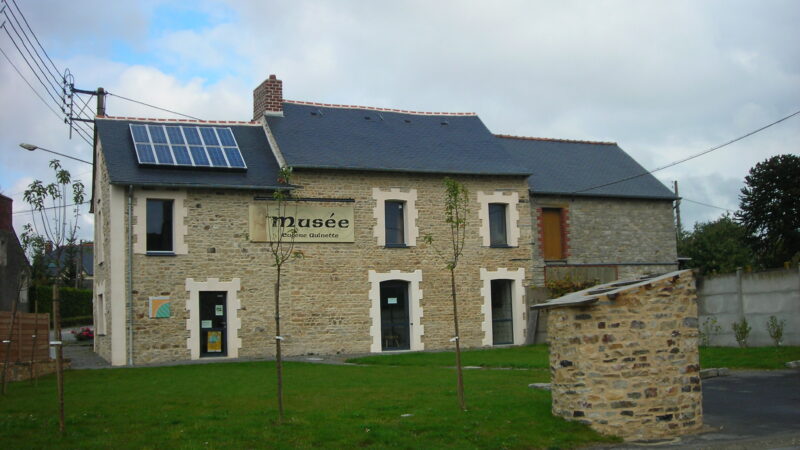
[0, 358, 614, 449]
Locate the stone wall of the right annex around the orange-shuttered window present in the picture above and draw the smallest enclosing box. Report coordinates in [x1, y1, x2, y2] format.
[531, 196, 677, 286]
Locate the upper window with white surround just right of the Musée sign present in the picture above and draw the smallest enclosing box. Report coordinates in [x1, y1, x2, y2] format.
[372, 188, 419, 247]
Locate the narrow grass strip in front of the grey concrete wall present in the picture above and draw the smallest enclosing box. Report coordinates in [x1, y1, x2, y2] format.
[700, 346, 800, 369]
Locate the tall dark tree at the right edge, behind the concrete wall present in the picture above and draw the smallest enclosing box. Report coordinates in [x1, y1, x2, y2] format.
[736, 154, 800, 267]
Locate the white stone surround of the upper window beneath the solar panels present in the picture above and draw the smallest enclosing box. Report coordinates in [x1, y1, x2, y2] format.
[133, 190, 189, 255]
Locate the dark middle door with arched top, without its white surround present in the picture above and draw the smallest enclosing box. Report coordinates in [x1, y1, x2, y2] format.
[381, 281, 411, 350]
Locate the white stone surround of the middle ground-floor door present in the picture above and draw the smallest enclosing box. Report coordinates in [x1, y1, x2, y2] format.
[369, 270, 425, 353]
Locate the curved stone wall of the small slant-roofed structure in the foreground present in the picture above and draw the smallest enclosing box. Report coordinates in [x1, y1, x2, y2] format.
[548, 271, 703, 440]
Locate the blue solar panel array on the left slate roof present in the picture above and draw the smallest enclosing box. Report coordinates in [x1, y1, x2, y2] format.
[130, 124, 247, 169]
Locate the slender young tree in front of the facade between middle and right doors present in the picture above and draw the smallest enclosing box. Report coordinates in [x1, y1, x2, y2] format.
[424, 177, 469, 411]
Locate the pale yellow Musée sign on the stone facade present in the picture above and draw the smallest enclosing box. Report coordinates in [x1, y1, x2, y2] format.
[250, 202, 355, 242]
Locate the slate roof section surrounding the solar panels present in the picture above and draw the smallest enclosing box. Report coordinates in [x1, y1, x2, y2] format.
[95, 117, 279, 189]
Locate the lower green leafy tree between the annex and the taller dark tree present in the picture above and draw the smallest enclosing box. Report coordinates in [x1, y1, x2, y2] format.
[678, 214, 755, 274]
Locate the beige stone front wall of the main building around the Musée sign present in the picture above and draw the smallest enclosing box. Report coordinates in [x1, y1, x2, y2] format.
[128, 170, 531, 364]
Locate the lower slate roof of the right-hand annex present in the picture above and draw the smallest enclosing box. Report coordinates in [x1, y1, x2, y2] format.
[497, 135, 675, 200]
